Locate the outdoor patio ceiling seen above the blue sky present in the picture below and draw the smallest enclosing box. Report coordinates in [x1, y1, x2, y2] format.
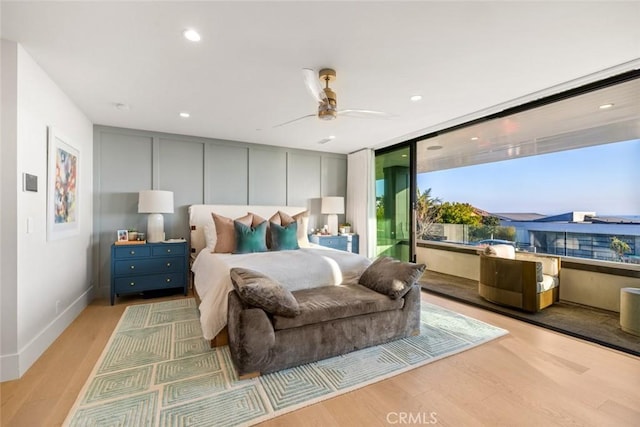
[416, 78, 640, 173]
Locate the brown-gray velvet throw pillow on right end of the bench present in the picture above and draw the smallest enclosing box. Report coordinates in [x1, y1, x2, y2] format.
[358, 257, 426, 299]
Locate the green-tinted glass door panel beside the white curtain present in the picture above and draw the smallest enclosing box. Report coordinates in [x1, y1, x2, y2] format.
[376, 144, 415, 261]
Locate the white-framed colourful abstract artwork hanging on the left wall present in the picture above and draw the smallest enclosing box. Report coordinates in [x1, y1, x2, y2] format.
[47, 127, 80, 240]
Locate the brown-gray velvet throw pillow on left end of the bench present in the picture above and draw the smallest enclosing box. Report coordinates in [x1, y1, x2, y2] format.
[230, 267, 300, 317]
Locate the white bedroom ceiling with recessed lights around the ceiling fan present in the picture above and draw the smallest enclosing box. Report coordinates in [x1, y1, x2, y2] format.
[0, 1, 640, 153]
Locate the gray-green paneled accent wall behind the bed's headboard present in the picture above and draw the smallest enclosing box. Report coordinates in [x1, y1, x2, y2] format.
[94, 126, 347, 296]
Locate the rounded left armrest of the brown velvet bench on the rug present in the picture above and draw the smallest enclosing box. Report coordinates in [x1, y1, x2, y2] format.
[227, 290, 275, 375]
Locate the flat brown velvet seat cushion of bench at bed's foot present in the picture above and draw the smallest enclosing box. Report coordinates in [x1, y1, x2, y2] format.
[273, 284, 404, 330]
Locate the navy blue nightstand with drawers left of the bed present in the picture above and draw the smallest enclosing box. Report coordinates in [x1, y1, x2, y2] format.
[111, 242, 189, 305]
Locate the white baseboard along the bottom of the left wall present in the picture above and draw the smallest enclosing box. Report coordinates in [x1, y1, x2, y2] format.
[0, 286, 95, 381]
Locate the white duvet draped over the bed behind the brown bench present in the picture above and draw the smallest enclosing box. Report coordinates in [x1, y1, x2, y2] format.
[191, 248, 371, 340]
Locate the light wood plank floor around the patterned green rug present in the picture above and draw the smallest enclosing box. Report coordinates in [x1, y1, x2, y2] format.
[0, 293, 640, 426]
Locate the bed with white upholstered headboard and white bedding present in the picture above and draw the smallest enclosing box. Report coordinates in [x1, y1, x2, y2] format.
[189, 205, 371, 342]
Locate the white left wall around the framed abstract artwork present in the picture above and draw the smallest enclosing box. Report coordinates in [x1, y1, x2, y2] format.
[0, 40, 93, 380]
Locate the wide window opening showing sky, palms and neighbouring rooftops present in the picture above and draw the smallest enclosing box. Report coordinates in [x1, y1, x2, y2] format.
[416, 73, 640, 263]
